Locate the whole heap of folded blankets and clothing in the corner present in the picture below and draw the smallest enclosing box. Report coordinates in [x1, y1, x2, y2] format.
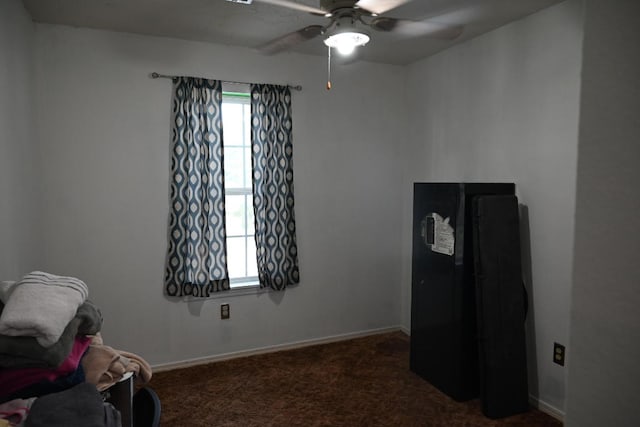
[0, 271, 151, 427]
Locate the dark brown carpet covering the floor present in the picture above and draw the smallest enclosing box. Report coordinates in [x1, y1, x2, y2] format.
[149, 332, 562, 427]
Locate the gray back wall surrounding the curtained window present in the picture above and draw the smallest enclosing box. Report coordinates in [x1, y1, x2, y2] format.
[30, 25, 406, 364]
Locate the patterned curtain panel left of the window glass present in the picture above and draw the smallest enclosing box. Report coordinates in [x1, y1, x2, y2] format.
[165, 77, 229, 297]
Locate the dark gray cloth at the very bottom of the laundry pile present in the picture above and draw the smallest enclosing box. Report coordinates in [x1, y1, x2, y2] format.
[25, 383, 111, 427]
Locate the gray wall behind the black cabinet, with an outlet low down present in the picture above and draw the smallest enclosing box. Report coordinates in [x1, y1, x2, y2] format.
[402, 1, 582, 415]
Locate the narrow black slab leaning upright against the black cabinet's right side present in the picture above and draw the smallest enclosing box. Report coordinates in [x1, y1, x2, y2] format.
[473, 196, 529, 418]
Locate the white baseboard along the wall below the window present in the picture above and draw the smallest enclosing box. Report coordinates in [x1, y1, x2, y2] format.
[152, 326, 406, 372]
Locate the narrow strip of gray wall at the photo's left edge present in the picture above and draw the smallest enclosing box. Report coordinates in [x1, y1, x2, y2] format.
[0, 0, 42, 280]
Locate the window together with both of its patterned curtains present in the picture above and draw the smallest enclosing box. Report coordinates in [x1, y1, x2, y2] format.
[165, 76, 300, 297]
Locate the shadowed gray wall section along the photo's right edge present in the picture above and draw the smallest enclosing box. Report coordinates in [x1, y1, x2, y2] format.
[566, 0, 640, 427]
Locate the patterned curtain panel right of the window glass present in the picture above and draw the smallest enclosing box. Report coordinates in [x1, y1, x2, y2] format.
[251, 84, 300, 290]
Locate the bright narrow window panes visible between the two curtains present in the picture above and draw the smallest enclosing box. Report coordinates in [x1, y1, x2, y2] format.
[222, 92, 258, 288]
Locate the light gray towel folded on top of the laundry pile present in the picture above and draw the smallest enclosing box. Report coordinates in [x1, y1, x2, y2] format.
[0, 271, 89, 347]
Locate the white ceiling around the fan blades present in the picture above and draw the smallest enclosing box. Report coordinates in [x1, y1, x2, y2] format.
[23, 0, 562, 65]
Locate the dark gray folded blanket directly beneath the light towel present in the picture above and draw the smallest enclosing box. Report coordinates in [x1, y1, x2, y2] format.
[0, 300, 102, 368]
